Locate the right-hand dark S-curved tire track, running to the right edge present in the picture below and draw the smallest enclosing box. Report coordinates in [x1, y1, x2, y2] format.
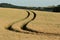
[21, 11, 60, 36]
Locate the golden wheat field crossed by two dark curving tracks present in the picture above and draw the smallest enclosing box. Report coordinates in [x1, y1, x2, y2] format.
[0, 8, 60, 40]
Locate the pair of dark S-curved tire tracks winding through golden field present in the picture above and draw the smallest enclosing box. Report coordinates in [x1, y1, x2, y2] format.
[7, 11, 60, 36]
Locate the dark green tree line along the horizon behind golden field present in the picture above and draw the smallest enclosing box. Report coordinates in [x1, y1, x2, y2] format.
[0, 3, 60, 12]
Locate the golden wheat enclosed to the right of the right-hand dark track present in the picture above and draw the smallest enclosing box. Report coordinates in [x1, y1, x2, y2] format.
[28, 11, 60, 34]
